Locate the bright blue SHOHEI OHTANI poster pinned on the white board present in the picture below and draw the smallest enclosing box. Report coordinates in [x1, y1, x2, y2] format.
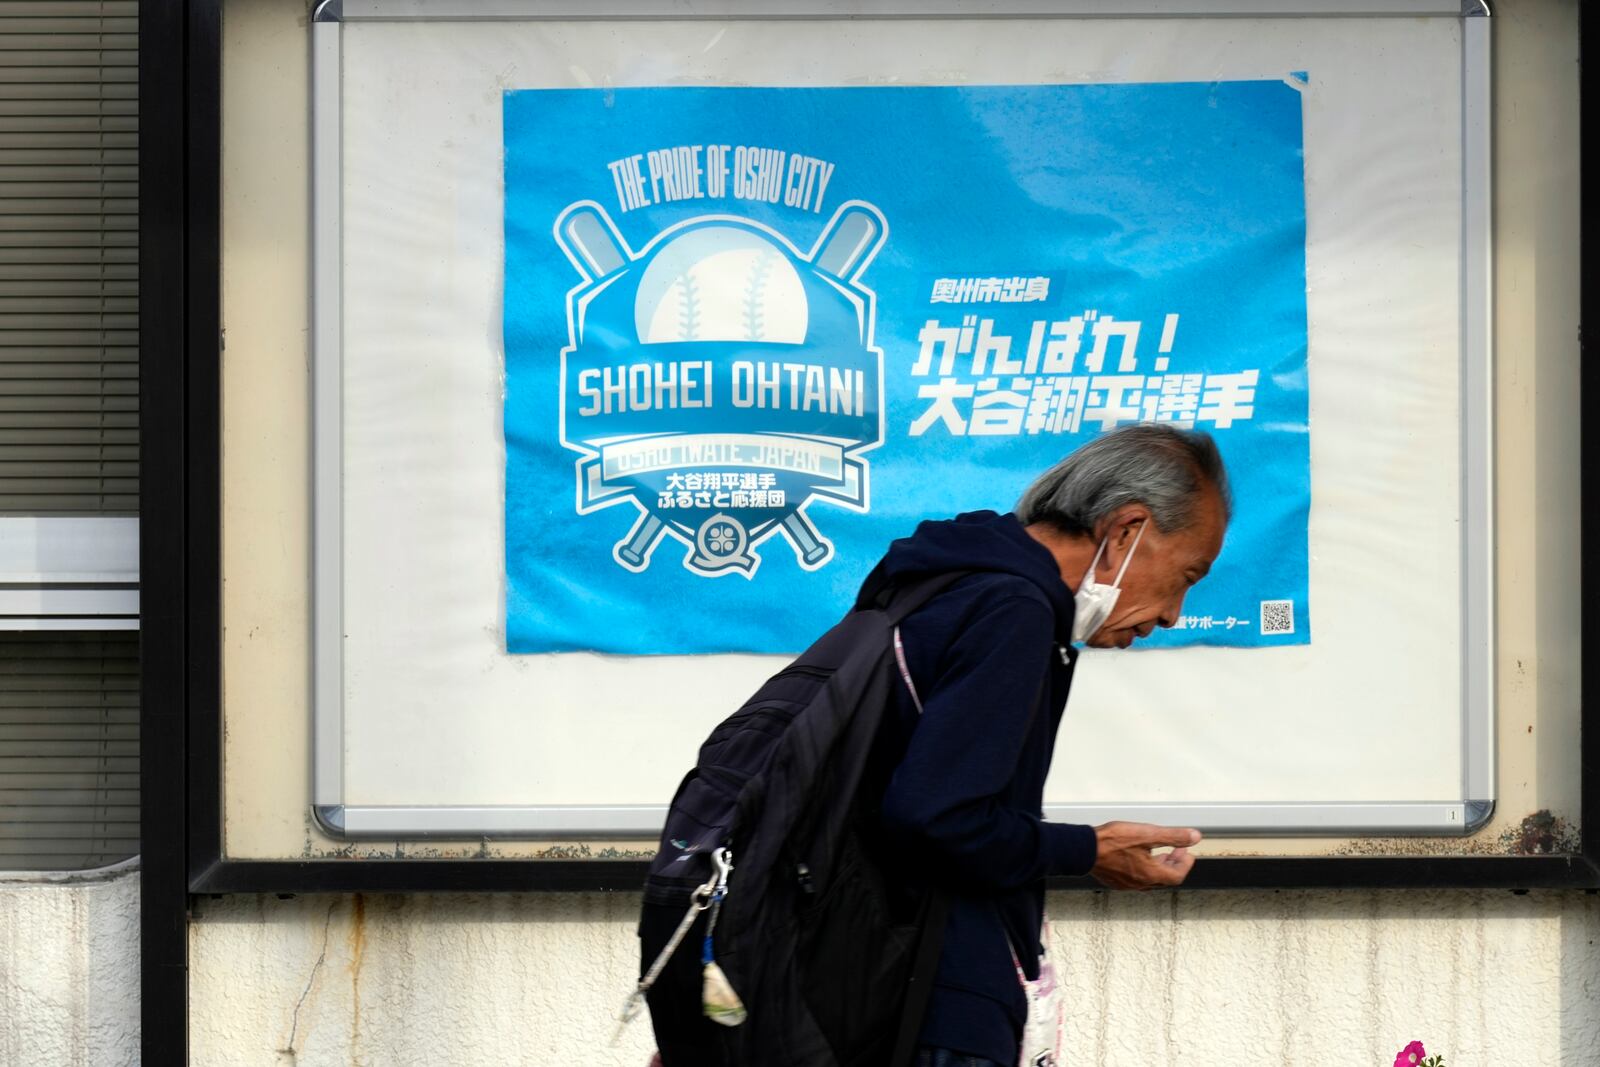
[504, 78, 1310, 654]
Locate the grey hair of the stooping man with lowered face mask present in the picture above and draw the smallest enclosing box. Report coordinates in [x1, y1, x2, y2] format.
[1016, 422, 1234, 534]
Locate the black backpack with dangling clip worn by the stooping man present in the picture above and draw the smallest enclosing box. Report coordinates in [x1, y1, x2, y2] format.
[638, 573, 963, 1067]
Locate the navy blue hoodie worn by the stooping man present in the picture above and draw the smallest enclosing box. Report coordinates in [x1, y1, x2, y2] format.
[858, 512, 1096, 1065]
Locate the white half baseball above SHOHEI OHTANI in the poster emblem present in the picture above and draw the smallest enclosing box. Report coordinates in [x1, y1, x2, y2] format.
[634, 226, 808, 344]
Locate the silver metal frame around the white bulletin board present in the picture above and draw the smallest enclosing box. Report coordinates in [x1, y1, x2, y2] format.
[300, 0, 1496, 840]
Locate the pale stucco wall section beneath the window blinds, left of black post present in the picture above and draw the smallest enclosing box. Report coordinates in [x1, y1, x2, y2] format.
[0, 861, 140, 1067]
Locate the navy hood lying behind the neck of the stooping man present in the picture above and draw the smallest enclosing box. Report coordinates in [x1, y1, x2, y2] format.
[856, 512, 1072, 648]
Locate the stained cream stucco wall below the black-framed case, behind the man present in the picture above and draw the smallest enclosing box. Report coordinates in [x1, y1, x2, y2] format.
[181, 891, 1600, 1067]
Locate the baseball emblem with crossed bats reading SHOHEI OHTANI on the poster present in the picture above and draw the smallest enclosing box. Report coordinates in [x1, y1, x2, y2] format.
[554, 200, 888, 577]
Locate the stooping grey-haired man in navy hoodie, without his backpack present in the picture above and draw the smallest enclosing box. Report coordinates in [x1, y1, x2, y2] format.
[858, 424, 1230, 1067]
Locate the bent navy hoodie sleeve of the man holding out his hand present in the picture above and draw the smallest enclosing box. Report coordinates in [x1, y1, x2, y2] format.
[882, 595, 1096, 889]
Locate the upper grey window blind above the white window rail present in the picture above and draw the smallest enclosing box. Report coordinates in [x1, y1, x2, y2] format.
[0, 0, 139, 515]
